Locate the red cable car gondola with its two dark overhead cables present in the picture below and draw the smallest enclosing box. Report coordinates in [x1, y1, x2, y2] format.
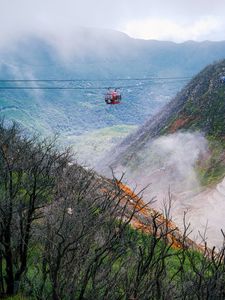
[0, 77, 191, 105]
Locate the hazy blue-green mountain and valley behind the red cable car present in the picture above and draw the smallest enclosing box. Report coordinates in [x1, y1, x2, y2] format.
[0, 28, 225, 163]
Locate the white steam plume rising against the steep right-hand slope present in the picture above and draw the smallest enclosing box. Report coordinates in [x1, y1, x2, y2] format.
[109, 133, 207, 199]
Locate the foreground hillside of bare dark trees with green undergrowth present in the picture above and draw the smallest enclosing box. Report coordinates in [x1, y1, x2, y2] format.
[0, 121, 225, 300]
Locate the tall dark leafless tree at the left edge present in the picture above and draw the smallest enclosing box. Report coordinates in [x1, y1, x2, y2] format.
[0, 122, 69, 295]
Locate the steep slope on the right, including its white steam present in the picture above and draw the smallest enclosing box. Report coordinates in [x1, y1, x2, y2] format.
[101, 61, 225, 247]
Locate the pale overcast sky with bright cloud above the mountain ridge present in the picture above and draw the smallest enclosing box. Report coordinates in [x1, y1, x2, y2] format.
[0, 0, 225, 43]
